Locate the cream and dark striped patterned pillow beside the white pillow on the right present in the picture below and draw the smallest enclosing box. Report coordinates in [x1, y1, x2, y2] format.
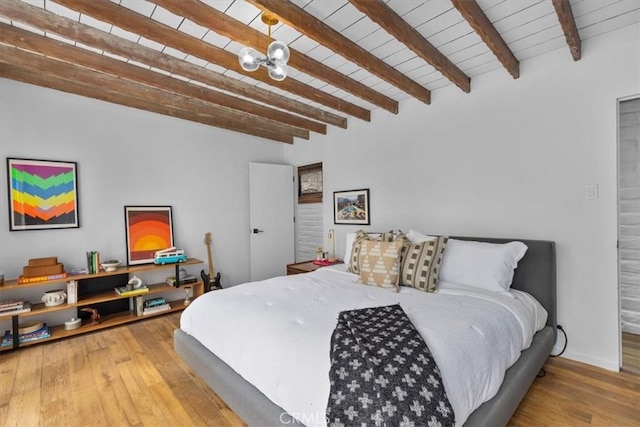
[400, 236, 449, 292]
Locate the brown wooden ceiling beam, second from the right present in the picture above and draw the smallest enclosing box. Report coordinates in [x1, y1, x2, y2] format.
[451, 0, 520, 79]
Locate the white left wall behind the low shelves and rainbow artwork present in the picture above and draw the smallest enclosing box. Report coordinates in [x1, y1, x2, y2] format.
[0, 79, 283, 285]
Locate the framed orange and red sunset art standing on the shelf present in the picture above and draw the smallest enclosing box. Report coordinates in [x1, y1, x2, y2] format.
[124, 206, 173, 265]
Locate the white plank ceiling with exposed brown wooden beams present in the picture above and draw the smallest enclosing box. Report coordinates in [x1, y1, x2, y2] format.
[0, 0, 640, 143]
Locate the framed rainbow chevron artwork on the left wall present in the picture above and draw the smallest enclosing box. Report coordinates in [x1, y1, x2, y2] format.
[7, 158, 80, 231]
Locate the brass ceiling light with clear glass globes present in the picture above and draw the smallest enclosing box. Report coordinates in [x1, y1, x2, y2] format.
[238, 13, 289, 82]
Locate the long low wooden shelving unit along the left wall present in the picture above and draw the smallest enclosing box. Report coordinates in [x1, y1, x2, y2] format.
[0, 258, 204, 352]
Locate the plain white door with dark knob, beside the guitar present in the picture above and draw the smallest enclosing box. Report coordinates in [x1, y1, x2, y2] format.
[249, 163, 295, 281]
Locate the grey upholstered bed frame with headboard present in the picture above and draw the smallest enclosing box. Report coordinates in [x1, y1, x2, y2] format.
[174, 236, 557, 426]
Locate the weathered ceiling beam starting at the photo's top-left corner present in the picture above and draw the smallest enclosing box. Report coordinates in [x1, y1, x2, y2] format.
[0, 0, 347, 129]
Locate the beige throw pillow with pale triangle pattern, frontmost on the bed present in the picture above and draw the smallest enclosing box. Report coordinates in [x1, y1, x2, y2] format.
[359, 240, 403, 292]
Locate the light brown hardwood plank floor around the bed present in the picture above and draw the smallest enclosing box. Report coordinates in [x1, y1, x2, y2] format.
[0, 313, 640, 427]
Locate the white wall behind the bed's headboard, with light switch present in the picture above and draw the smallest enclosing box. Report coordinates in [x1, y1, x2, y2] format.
[285, 25, 640, 369]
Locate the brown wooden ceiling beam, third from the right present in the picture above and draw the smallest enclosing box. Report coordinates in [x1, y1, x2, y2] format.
[349, 0, 471, 93]
